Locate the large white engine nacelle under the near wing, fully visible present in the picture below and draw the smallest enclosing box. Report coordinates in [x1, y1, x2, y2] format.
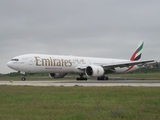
[85, 65, 104, 77]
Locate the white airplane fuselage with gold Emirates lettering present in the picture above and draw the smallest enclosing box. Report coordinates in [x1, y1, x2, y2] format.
[7, 54, 139, 73]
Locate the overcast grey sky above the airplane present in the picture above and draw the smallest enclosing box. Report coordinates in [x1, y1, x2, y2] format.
[0, 0, 160, 73]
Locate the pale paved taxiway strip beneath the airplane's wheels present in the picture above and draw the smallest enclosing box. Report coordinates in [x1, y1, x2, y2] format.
[0, 80, 160, 87]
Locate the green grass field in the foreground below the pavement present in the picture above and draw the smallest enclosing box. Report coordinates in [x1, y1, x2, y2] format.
[0, 86, 160, 120]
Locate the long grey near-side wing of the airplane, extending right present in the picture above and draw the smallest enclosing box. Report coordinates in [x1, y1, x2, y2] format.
[102, 60, 155, 68]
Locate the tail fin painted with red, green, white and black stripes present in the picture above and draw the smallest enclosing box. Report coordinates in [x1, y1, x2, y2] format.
[130, 41, 144, 61]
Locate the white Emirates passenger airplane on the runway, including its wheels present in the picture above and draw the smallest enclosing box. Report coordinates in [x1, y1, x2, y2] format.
[7, 41, 154, 81]
